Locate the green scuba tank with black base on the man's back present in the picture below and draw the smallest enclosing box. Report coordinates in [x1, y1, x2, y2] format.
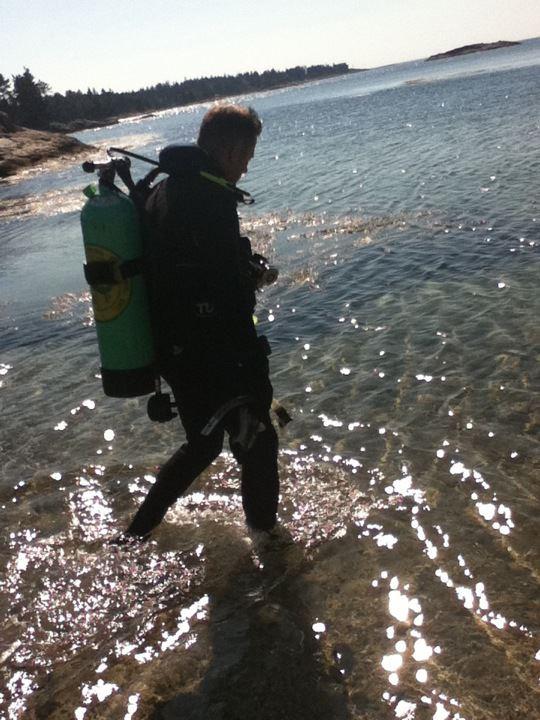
[81, 182, 155, 397]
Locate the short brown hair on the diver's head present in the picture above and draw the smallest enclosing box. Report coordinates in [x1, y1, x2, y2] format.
[197, 104, 262, 153]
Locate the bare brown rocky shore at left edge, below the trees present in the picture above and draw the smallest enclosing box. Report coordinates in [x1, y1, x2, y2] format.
[0, 113, 93, 178]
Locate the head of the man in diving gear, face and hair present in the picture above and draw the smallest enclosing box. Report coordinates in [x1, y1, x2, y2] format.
[197, 105, 262, 183]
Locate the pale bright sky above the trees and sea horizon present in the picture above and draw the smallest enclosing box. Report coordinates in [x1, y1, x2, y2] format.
[0, 0, 540, 93]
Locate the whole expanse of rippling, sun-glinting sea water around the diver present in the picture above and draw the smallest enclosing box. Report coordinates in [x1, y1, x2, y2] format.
[0, 40, 540, 720]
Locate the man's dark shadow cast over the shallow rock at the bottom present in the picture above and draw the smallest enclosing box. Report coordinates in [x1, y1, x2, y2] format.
[153, 545, 351, 720]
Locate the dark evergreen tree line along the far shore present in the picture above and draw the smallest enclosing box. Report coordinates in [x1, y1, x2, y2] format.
[0, 63, 349, 130]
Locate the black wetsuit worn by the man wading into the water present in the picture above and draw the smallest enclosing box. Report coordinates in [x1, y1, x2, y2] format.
[128, 146, 279, 536]
